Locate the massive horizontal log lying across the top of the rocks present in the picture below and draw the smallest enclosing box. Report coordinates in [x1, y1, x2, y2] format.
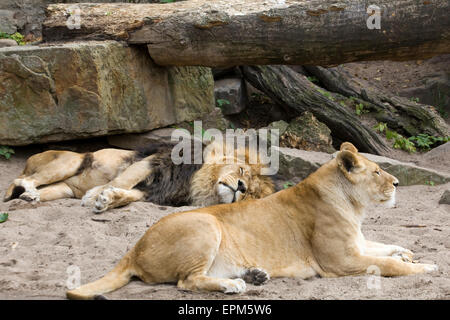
[44, 0, 450, 67]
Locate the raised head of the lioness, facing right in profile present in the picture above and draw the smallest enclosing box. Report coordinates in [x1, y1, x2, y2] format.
[337, 142, 398, 207]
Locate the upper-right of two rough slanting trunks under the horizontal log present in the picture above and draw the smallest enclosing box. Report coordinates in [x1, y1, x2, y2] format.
[305, 67, 449, 136]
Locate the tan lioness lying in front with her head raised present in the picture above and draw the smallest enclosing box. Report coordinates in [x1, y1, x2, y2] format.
[67, 142, 437, 299]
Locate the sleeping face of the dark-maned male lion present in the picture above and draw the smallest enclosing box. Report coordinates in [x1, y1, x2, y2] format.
[216, 164, 251, 203]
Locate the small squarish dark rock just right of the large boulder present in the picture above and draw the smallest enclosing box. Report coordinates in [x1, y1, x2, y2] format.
[214, 78, 247, 115]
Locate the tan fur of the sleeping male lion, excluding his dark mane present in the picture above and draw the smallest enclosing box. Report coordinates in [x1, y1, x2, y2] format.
[4, 144, 274, 213]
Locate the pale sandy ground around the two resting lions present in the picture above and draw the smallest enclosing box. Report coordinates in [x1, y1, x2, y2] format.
[0, 149, 450, 299]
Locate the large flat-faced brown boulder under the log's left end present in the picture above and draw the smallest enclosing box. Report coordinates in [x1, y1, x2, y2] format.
[0, 41, 214, 145]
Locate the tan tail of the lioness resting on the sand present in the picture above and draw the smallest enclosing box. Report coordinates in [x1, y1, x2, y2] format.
[66, 250, 135, 300]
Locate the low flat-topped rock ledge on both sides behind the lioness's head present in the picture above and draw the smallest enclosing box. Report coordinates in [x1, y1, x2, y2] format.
[277, 148, 450, 186]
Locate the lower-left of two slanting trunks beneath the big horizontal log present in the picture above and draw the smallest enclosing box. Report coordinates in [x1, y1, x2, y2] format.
[242, 66, 387, 154]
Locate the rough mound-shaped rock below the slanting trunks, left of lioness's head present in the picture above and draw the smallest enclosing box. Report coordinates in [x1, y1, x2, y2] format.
[280, 111, 336, 153]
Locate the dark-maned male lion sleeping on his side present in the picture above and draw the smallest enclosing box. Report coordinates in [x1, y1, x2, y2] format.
[4, 144, 274, 213]
